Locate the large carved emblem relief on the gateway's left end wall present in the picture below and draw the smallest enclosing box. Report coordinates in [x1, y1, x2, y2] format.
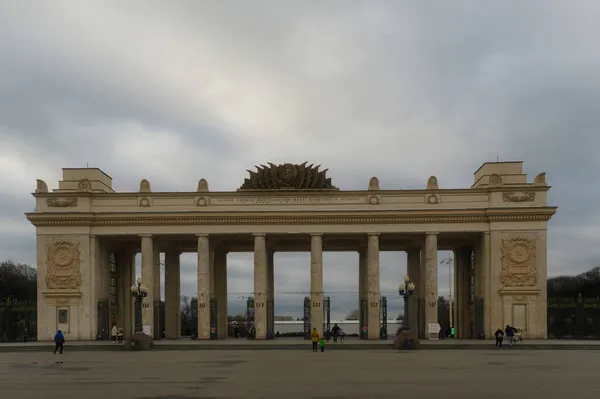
[46, 240, 81, 290]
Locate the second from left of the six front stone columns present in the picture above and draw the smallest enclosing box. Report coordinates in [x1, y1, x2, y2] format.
[196, 234, 212, 339]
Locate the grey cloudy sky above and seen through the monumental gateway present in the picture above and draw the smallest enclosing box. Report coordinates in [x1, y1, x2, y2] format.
[0, 0, 600, 317]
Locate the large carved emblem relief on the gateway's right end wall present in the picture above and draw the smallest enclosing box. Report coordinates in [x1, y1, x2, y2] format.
[500, 237, 537, 287]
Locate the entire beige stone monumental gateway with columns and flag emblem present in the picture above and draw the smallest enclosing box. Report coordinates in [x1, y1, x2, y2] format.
[26, 162, 556, 340]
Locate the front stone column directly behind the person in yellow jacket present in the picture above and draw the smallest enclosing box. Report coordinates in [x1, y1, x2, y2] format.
[310, 234, 323, 337]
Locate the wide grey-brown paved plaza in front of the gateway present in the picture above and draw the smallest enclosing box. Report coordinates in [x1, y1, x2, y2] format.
[0, 349, 600, 399]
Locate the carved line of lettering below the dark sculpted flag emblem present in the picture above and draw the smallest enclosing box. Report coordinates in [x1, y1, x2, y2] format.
[210, 195, 366, 205]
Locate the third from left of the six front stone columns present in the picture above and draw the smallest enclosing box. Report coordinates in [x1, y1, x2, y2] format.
[254, 234, 269, 339]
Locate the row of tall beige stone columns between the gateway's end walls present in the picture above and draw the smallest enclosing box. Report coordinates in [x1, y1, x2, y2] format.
[105, 233, 486, 339]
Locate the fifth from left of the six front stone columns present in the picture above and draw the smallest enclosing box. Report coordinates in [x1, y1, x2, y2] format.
[367, 233, 381, 339]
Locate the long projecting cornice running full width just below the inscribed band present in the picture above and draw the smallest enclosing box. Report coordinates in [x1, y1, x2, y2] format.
[26, 207, 556, 226]
